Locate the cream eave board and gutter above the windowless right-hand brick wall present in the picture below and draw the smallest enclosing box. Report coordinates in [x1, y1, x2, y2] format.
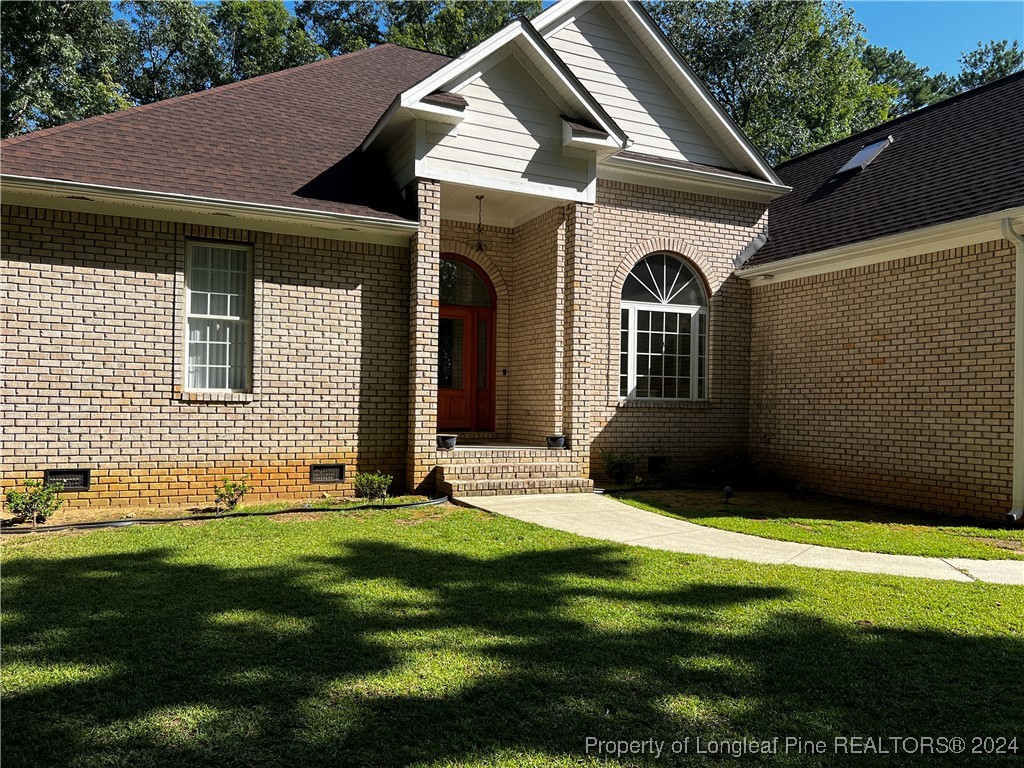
[735, 207, 1024, 286]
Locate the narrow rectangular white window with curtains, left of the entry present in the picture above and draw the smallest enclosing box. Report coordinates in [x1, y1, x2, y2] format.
[185, 243, 252, 392]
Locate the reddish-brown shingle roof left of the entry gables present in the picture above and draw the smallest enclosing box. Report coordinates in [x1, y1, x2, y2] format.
[0, 45, 450, 219]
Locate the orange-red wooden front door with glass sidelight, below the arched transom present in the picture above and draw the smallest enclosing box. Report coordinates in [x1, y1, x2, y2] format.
[437, 306, 495, 432]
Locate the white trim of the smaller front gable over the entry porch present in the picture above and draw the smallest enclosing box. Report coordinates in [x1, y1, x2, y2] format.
[362, 20, 629, 150]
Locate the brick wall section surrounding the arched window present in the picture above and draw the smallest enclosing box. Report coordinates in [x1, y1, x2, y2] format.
[587, 182, 765, 480]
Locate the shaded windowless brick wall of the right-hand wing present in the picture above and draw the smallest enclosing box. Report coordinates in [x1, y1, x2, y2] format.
[751, 241, 1014, 519]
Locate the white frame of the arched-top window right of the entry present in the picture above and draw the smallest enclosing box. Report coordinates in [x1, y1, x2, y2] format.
[615, 252, 710, 402]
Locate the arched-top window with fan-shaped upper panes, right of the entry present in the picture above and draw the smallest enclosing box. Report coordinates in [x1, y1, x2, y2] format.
[618, 253, 708, 399]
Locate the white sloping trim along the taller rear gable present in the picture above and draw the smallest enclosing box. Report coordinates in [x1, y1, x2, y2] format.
[532, 0, 784, 187]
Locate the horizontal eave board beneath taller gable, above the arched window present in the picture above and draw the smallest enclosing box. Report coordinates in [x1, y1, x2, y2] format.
[597, 155, 793, 203]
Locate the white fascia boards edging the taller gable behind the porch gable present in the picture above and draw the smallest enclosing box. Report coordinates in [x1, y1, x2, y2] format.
[532, 0, 782, 186]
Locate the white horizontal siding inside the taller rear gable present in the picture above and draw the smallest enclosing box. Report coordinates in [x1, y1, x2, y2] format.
[545, 3, 734, 168]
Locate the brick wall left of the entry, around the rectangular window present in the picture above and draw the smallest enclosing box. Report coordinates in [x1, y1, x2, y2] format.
[0, 206, 410, 512]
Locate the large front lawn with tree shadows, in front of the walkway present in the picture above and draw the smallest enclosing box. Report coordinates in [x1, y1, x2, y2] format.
[2, 508, 1024, 768]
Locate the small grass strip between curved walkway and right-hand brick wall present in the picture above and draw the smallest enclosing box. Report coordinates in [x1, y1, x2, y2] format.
[615, 490, 1024, 560]
